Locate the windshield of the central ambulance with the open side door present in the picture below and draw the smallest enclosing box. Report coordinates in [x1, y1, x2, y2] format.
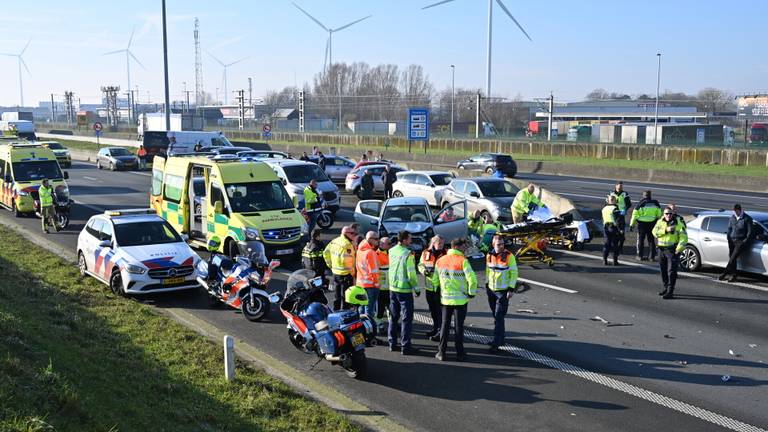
[225, 181, 293, 213]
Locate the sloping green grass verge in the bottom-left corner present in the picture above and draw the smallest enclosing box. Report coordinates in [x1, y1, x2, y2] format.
[0, 226, 359, 431]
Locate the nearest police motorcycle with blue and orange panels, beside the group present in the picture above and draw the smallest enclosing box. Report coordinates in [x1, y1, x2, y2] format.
[280, 270, 375, 379]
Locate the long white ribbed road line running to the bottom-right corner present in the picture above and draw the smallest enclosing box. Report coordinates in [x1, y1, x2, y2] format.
[413, 313, 766, 432]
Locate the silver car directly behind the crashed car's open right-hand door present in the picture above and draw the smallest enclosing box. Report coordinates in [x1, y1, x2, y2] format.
[441, 177, 520, 222]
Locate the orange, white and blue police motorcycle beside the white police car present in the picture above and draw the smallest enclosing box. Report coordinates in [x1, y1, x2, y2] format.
[197, 237, 280, 322]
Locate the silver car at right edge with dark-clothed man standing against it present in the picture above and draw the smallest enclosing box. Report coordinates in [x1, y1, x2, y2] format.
[680, 211, 768, 276]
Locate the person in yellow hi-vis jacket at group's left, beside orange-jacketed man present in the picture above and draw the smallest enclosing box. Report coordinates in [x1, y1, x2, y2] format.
[323, 226, 357, 310]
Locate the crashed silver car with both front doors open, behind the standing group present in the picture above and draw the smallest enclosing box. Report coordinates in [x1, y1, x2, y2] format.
[355, 197, 467, 253]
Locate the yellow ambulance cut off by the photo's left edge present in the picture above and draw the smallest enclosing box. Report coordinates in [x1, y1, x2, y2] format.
[0, 142, 69, 217]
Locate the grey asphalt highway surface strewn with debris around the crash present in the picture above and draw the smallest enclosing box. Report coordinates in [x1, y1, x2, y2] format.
[0, 162, 768, 432]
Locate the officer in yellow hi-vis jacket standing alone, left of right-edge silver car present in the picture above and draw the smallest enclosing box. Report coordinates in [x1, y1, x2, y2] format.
[653, 206, 688, 300]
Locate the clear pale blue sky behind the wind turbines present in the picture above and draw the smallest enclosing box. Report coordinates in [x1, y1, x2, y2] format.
[0, 0, 768, 105]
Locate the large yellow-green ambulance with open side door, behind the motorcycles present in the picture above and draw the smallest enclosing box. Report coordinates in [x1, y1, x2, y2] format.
[150, 155, 308, 258]
